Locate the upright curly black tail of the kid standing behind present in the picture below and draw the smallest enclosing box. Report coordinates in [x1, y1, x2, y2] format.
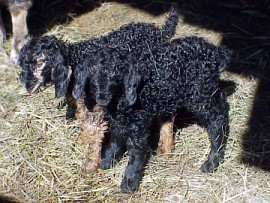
[162, 2, 179, 39]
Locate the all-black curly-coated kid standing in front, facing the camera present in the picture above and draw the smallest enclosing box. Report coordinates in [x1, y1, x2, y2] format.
[85, 37, 231, 192]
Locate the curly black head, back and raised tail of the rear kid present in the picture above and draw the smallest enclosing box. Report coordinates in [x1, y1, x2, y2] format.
[19, 3, 179, 98]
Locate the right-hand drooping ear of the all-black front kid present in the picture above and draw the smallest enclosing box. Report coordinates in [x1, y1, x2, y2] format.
[124, 67, 141, 106]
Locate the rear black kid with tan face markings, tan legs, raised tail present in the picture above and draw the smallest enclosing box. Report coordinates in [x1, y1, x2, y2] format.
[19, 1, 178, 173]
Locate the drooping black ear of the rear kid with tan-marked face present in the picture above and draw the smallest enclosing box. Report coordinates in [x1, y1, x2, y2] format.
[53, 52, 72, 97]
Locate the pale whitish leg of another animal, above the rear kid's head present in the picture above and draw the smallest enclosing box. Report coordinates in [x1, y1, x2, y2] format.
[9, 1, 31, 64]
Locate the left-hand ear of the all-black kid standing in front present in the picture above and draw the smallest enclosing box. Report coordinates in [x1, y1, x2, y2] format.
[72, 63, 88, 99]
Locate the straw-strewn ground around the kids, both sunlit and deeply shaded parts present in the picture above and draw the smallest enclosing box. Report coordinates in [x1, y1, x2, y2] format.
[0, 1, 270, 203]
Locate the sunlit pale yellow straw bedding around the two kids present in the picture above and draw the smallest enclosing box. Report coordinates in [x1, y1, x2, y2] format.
[0, 2, 270, 202]
